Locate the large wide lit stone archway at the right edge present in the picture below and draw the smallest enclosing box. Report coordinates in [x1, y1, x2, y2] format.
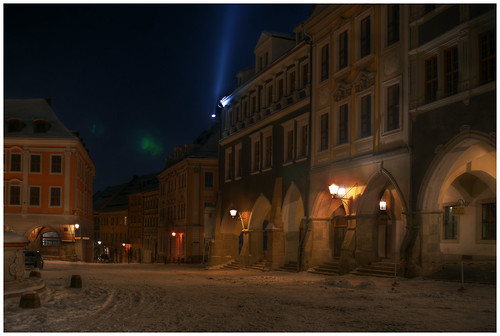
[416, 129, 496, 268]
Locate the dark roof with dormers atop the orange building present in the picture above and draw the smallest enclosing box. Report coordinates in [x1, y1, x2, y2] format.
[4, 99, 77, 139]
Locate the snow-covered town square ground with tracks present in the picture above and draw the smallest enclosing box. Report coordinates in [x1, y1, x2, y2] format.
[4, 261, 496, 332]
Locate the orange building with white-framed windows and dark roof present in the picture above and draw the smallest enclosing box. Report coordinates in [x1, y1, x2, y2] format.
[4, 99, 95, 261]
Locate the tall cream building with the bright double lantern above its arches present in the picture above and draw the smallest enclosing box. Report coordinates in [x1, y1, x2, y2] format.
[303, 4, 411, 273]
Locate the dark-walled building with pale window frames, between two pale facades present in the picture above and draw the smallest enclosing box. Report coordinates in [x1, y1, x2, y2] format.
[210, 29, 311, 269]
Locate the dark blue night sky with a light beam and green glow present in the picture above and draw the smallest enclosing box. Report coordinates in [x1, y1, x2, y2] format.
[4, 4, 311, 191]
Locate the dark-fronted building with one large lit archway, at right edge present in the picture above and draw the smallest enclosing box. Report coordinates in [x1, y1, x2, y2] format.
[406, 4, 497, 273]
